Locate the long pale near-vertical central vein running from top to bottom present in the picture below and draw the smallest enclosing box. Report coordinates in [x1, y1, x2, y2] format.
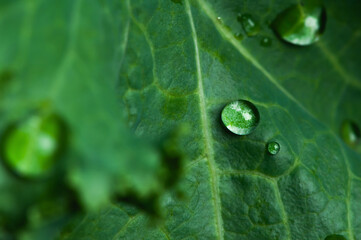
[185, 0, 224, 240]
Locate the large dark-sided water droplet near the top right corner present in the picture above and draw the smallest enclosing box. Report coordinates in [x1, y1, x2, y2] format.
[271, 4, 326, 46]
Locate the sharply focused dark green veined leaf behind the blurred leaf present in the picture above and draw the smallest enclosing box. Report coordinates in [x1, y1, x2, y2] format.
[69, 0, 361, 240]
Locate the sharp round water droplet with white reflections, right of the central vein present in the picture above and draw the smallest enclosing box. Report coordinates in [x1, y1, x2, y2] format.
[221, 100, 260, 135]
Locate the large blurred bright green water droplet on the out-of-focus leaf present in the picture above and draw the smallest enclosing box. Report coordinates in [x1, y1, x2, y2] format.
[1, 113, 65, 177]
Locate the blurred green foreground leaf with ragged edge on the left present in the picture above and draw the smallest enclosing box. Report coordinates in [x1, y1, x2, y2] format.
[0, 0, 179, 236]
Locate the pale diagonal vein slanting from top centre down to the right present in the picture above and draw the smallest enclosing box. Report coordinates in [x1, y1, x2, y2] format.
[198, 0, 317, 124]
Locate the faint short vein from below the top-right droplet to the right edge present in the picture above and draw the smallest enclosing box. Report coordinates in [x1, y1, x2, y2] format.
[317, 41, 361, 89]
